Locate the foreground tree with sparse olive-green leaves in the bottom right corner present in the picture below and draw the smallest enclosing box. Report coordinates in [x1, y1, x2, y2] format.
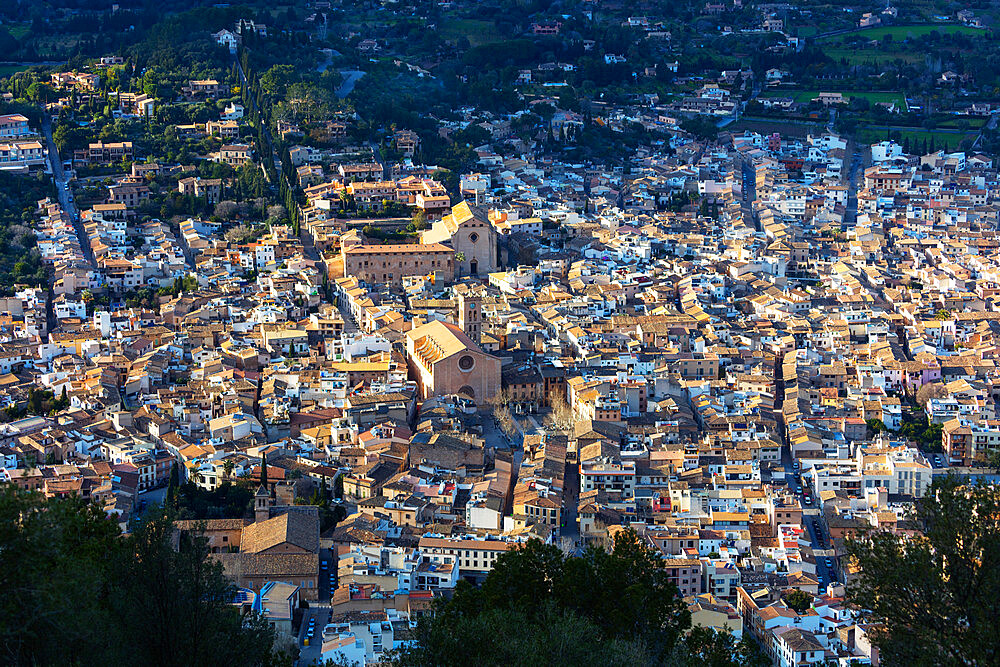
[847, 476, 1000, 665]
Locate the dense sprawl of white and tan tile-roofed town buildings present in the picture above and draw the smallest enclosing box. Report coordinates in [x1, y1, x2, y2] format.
[0, 24, 1000, 665]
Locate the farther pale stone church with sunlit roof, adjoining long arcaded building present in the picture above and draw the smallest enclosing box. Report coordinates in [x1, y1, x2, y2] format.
[420, 201, 498, 279]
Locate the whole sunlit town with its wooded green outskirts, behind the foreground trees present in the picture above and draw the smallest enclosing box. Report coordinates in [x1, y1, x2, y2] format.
[0, 0, 1000, 667]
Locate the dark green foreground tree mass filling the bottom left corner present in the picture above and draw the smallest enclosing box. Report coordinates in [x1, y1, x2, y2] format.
[0, 485, 279, 667]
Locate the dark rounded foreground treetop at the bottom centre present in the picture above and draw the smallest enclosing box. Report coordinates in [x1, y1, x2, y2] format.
[397, 530, 691, 665]
